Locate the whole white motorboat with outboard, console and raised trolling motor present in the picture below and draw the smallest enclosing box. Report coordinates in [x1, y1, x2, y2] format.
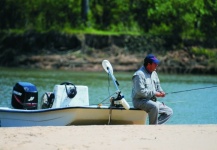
[0, 60, 147, 127]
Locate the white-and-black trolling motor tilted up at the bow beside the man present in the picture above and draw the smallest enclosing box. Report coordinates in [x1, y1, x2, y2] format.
[102, 60, 130, 110]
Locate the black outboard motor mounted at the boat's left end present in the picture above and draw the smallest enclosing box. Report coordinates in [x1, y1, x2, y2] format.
[11, 82, 38, 109]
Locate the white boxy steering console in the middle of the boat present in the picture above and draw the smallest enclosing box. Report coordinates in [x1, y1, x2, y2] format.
[52, 85, 89, 108]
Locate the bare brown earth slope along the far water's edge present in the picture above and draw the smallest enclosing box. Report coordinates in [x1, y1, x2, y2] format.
[13, 49, 217, 74]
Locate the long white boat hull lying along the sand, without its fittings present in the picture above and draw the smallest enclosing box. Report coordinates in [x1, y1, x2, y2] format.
[0, 106, 147, 127]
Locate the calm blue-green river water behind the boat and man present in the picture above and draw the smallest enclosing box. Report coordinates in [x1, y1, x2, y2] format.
[0, 68, 217, 124]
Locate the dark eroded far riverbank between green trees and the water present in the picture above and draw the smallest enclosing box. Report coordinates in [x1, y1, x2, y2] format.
[0, 32, 217, 75]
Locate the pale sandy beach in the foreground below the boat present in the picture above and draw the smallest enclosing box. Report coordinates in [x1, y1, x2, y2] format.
[0, 125, 217, 150]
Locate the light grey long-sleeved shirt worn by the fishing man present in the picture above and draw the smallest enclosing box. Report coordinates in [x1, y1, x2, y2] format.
[131, 66, 163, 100]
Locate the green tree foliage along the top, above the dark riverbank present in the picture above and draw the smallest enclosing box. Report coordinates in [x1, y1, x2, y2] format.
[0, 0, 217, 47]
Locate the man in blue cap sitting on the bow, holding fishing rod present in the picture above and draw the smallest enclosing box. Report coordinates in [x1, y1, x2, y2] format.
[132, 54, 173, 125]
